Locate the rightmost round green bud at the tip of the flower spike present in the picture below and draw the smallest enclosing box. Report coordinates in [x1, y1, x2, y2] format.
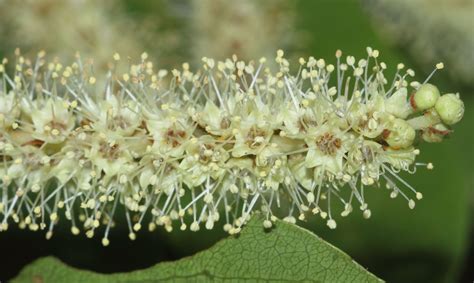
[435, 93, 464, 125]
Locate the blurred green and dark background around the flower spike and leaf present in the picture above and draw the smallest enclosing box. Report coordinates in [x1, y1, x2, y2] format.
[0, 0, 474, 282]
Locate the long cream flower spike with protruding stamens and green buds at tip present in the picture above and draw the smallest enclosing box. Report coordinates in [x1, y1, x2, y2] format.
[0, 48, 464, 245]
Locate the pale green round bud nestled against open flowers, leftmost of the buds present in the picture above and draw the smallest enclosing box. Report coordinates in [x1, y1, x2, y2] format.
[383, 118, 416, 149]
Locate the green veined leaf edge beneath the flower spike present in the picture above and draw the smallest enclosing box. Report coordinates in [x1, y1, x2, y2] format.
[13, 215, 382, 283]
